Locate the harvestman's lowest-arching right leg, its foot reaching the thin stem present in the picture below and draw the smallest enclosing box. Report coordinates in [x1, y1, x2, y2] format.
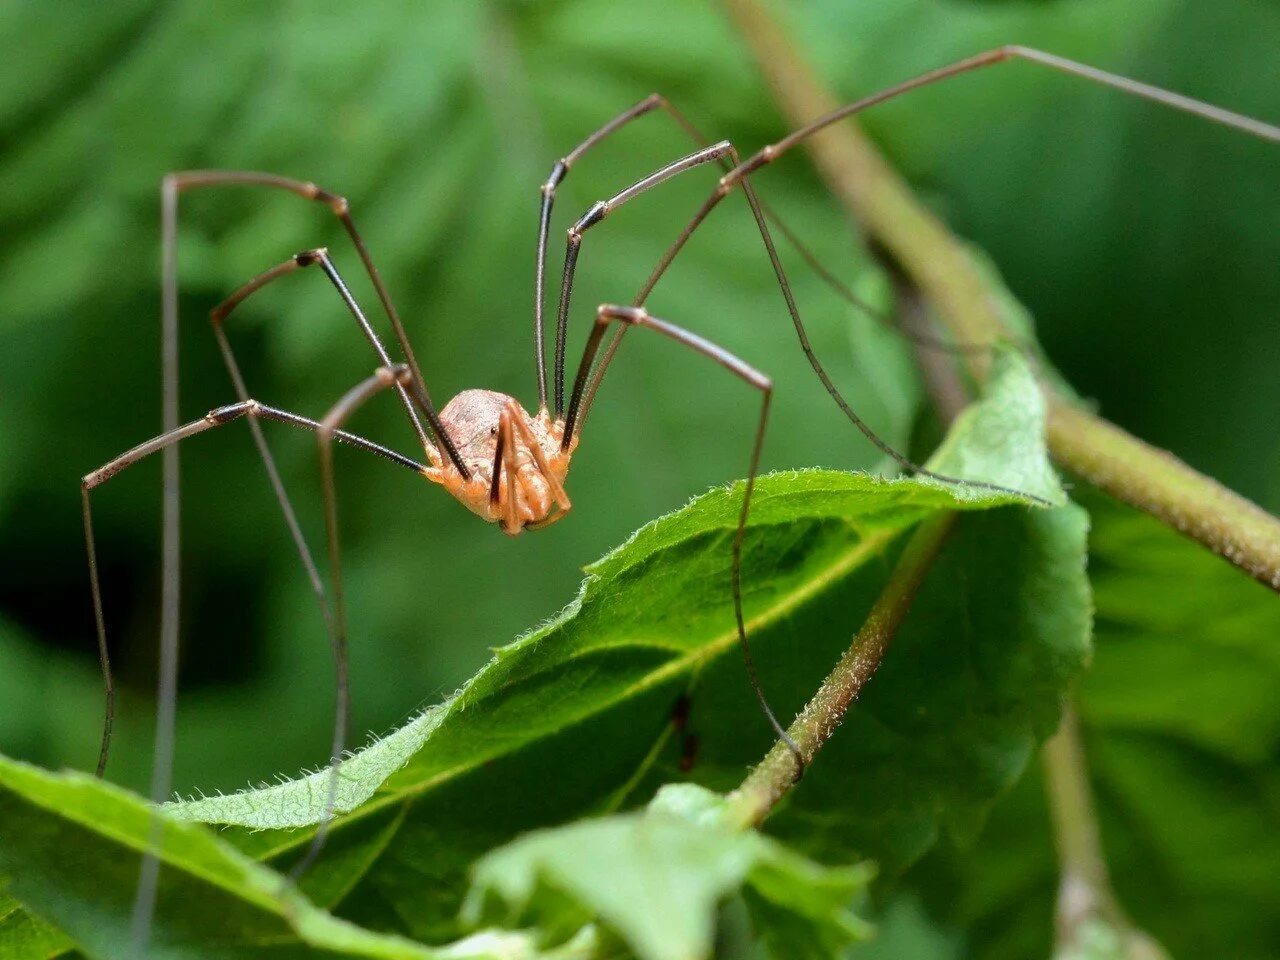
[562, 305, 804, 780]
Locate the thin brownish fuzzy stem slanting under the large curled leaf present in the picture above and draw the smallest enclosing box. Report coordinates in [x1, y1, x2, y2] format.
[730, 513, 955, 827]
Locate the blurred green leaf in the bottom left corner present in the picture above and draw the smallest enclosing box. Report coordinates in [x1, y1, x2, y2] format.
[0, 758, 581, 960]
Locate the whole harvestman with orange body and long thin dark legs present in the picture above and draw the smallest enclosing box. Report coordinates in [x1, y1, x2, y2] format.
[82, 46, 1280, 936]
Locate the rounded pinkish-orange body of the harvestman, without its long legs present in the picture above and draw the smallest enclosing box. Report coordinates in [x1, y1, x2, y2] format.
[425, 390, 576, 536]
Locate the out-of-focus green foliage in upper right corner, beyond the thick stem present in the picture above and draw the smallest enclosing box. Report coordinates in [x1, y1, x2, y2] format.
[798, 0, 1280, 511]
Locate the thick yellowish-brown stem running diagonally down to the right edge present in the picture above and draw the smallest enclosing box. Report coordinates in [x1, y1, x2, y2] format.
[724, 0, 1280, 591]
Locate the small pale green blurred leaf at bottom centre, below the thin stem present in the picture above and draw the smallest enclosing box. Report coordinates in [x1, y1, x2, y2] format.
[465, 785, 870, 960]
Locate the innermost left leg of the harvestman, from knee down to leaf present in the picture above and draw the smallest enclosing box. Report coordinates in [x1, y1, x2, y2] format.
[289, 365, 410, 881]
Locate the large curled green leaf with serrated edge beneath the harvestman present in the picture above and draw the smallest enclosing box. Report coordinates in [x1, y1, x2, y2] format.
[145, 353, 1089, 940]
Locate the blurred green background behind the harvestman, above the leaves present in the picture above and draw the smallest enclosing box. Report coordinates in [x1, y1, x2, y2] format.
[0, 0, 1280, 957]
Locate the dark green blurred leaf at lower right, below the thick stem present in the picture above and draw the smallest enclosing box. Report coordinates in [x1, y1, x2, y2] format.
[918, 488, 1280, 960]
